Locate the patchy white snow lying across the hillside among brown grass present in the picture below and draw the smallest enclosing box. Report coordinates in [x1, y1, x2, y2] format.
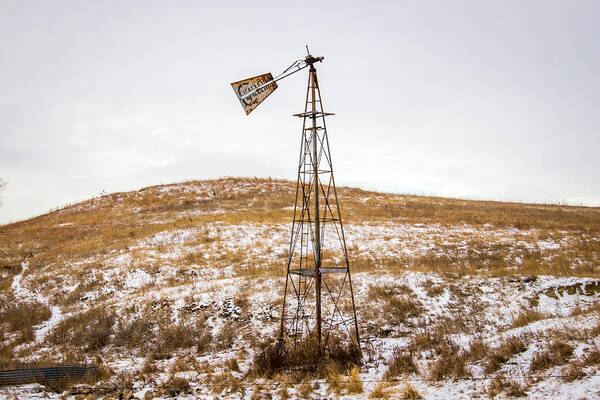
[0, 205, 600, 399]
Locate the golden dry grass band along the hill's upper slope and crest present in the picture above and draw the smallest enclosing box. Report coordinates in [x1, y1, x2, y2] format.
[0, 178, 600, 294]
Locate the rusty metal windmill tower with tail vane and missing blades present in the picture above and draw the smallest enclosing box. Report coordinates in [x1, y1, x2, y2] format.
[231, 46, 360, 353]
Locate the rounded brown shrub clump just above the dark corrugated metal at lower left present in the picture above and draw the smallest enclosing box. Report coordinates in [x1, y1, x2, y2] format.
[46, 307, 115, 351]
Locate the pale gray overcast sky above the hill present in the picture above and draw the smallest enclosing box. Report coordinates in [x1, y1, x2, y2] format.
[0, 0, 600, 223]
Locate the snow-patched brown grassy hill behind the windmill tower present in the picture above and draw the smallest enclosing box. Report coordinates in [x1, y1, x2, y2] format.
[0, 178, 600, 399]
